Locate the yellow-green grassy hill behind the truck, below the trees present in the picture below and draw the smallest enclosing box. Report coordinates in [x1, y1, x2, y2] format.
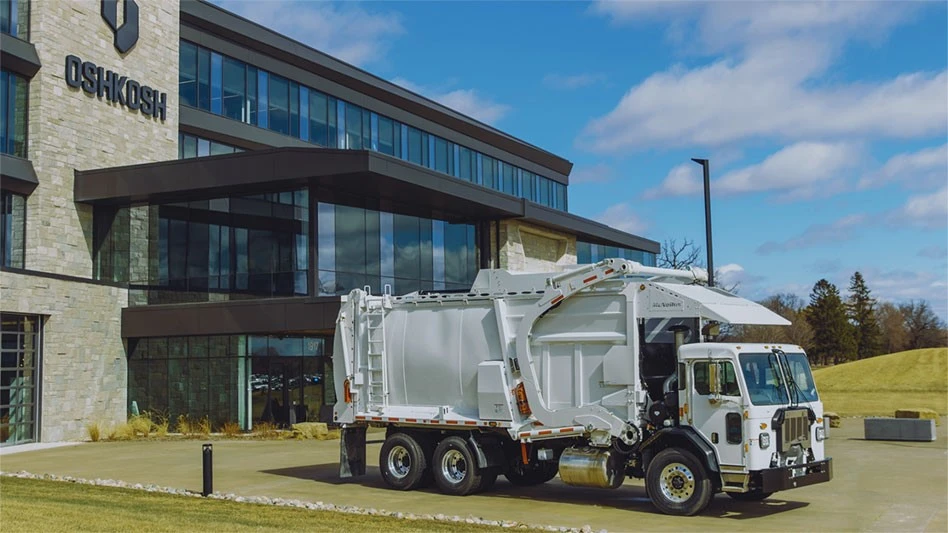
[813, 348, 948, 416]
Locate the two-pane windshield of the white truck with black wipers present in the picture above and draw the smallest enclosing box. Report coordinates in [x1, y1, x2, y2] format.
[740, 353, 819, 405]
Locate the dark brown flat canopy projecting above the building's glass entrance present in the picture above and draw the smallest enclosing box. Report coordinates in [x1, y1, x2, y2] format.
[75, 148, 659, 253]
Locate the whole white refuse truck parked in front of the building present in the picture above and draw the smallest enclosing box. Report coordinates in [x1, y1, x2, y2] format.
[333, 259, 832, 515]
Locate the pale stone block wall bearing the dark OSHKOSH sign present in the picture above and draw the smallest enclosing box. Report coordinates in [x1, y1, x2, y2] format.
[0, 0, 180, 441]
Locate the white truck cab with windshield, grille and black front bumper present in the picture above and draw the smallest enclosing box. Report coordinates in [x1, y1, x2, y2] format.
[677, 343, 831, 500]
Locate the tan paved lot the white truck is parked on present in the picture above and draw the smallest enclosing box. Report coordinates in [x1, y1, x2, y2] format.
[0, 419, 948, 532]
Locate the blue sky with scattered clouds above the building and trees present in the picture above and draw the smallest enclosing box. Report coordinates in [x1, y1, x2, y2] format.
[220, 0, 948, 319]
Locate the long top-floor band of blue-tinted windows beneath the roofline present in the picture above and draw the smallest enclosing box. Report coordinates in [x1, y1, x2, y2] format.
[178, 41, 568, 211]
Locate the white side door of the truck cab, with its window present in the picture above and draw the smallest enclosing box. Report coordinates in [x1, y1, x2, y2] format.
[690, 360, 744, 466]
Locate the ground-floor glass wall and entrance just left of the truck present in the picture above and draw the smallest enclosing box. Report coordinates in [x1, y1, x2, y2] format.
[128, 335, 336, 430]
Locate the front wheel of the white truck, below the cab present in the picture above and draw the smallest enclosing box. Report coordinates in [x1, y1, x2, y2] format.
[645, 448, 714, 516]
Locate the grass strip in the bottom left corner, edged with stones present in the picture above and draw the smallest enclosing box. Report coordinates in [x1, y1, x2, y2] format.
[0, 477, 501, 533]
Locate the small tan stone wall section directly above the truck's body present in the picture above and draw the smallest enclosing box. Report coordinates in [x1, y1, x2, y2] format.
[491, 220, 576, 272]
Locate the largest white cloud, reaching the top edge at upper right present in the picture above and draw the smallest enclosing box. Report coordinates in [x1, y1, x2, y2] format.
[577, 2, 948, 153]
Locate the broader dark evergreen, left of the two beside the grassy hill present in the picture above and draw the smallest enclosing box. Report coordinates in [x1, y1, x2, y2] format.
[806, 279, 856, 365]
